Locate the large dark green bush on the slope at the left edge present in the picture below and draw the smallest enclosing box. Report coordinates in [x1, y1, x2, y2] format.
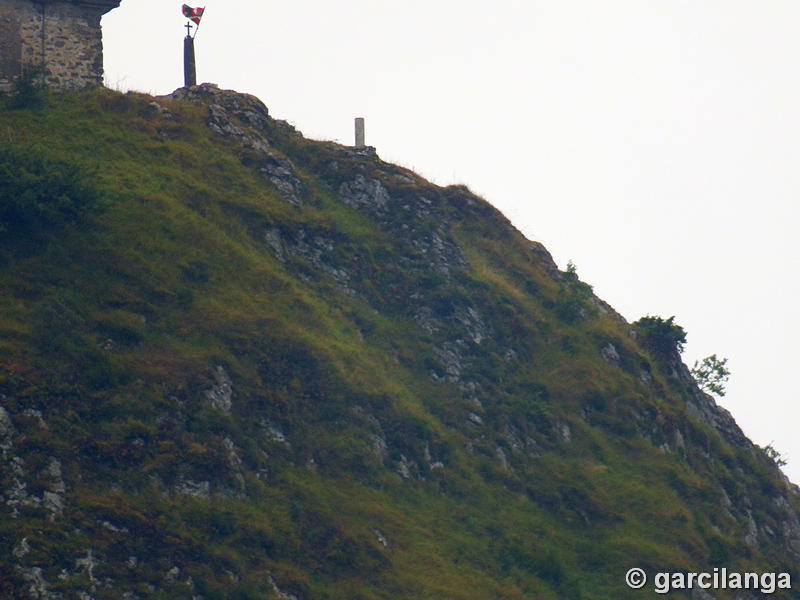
[0, 144, 102, 237]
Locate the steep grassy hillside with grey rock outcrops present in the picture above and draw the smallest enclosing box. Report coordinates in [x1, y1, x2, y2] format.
[0, 86, 800, 600]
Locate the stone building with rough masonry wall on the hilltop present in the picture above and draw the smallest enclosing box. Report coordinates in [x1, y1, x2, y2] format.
[0, 0, 120, 91]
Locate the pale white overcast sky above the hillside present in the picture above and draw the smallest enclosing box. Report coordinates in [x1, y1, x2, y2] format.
[102, 0, 800, 483]
